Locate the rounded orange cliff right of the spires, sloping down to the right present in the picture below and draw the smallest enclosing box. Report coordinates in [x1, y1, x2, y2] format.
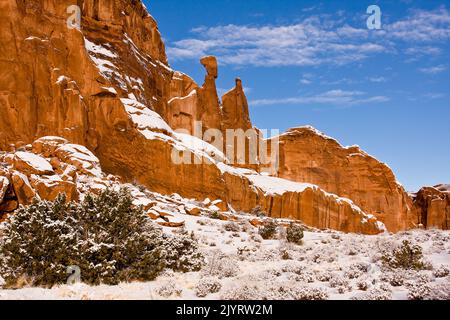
[268, 127, 412, 232]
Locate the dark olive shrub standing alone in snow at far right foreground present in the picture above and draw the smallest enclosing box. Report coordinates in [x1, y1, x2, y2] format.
[381, 240, 426, 270]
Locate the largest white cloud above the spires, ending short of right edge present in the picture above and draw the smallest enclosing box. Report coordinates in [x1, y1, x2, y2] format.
[168, 16, 386, 66]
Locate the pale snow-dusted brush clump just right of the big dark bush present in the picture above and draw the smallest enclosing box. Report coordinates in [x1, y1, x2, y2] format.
[202, 250, 240, 279]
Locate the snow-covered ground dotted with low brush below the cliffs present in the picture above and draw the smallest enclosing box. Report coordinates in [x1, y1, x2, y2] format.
[0, 208, 450, 300]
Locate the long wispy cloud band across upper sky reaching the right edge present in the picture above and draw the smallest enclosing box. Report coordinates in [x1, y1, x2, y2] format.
[168, 7, 450, 67]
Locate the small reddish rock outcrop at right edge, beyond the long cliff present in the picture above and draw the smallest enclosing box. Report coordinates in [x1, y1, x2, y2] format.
[411, 185, 450, 230]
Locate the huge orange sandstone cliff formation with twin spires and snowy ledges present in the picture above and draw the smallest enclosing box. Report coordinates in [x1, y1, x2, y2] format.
[0, 0, 442, 233]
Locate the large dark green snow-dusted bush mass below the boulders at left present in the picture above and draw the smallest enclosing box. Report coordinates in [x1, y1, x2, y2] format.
[0, 189, 204, 286]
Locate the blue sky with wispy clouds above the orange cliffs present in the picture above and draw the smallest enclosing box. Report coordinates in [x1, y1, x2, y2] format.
[144, 0, 450, 191]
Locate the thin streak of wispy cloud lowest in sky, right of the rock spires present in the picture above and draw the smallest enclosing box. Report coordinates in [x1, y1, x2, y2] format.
[250, 89, 389, 106]
